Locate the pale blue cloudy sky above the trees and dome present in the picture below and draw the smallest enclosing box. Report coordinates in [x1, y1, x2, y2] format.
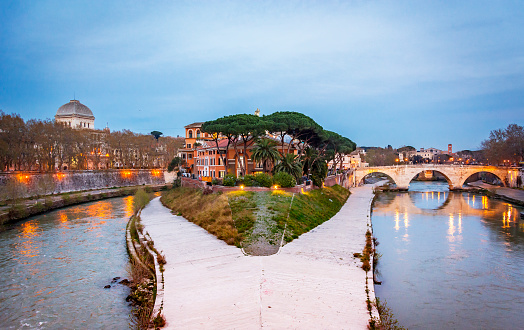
[0, 0, 524, 150]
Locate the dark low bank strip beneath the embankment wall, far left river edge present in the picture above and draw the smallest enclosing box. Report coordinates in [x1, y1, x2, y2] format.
[0, 184, 165, 231]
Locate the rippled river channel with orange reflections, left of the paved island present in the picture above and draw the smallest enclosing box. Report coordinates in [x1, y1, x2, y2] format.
[0, 196, 133, 329]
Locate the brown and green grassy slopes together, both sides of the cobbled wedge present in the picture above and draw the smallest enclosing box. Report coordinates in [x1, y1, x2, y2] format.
[161, 186, 349, 246]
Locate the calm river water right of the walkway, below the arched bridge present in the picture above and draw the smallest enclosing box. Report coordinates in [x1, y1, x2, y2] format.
[372, 182, 524, 329]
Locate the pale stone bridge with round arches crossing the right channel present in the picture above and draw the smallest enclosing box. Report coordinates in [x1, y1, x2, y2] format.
[352, 164, 521, 190]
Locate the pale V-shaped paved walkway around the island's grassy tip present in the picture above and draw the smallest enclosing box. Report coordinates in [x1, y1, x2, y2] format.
[141, 186, 374, 329]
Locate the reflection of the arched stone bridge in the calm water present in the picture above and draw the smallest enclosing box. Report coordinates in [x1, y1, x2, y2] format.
[373, 191, 520, 227]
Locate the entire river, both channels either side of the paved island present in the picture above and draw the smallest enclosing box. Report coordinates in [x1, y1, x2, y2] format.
[0, 182, 524, 329]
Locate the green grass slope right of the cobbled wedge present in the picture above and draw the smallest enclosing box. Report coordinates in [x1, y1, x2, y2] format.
[275, 185, 349, 242]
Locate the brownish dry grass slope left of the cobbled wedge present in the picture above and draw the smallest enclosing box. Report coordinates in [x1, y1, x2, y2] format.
[160, 187, 243, 246]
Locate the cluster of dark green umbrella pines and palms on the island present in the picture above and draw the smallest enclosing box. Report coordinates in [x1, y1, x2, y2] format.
[201, 111, 356, 187]
